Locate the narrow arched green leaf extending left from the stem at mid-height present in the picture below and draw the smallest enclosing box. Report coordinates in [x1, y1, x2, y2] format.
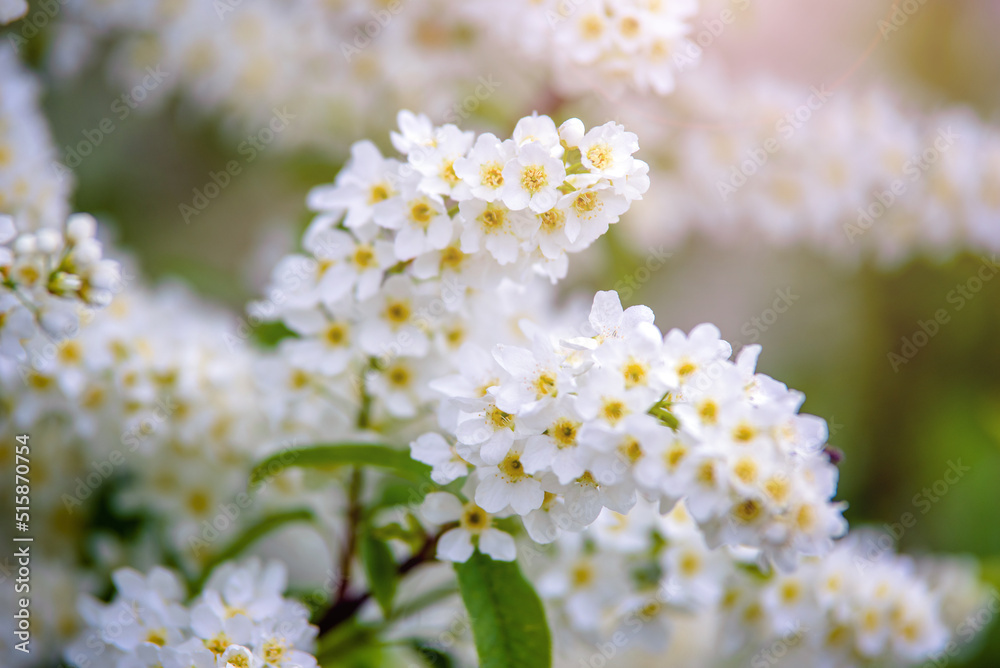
[250, 443, 431, 485]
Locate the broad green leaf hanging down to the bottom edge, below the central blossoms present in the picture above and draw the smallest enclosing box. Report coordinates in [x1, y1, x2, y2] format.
[455, 552, 552, 668]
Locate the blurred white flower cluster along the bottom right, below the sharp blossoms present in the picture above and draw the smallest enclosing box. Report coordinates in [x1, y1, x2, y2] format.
[535, 502, 984, 668]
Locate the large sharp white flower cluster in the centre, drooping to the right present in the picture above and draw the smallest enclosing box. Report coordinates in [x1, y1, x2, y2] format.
[411, 292, 846, 568]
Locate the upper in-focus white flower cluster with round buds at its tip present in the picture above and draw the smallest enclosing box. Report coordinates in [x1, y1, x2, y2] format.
[304, 111, 649, 280]
